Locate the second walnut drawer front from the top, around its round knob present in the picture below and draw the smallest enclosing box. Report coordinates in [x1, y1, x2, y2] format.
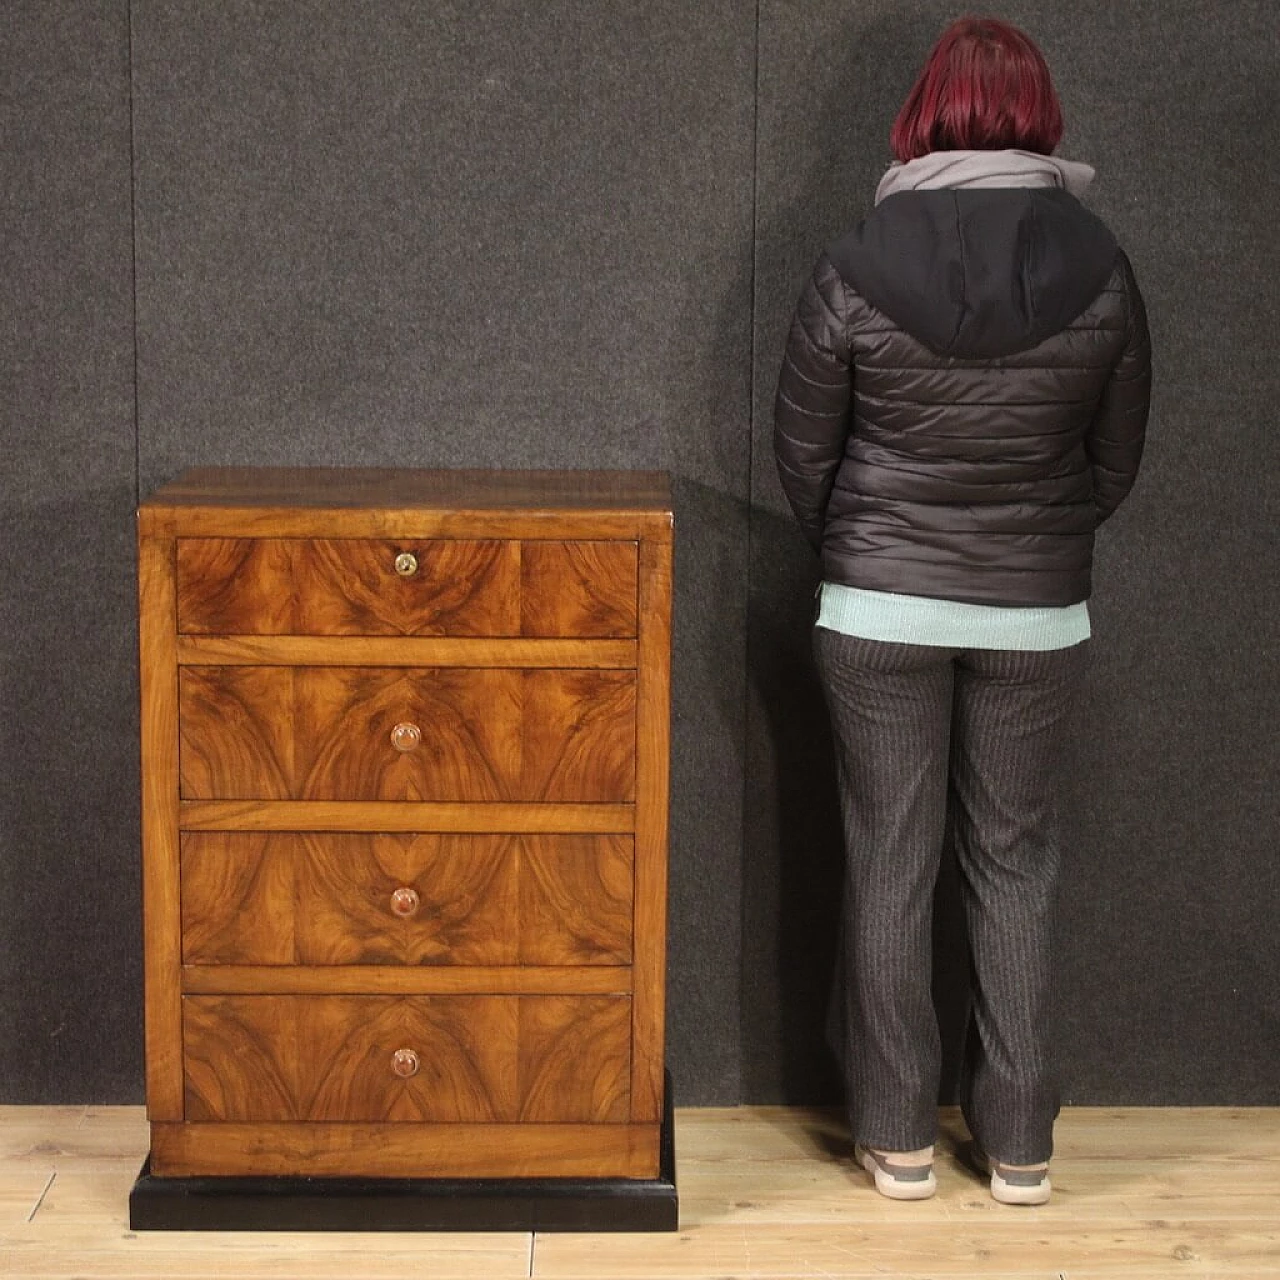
[179, 667, 636, 803]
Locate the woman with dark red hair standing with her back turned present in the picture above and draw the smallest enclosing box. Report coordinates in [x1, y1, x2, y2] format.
[774, 18, 1151, 1203]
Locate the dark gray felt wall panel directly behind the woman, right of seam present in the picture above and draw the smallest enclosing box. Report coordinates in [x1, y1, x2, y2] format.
[741, 0, 1280, 1103]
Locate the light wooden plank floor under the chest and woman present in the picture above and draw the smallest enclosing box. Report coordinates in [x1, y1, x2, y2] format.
[0, 1107, 1280, 1280]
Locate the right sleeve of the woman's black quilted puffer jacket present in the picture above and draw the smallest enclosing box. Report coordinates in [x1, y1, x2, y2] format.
[1084, 252, 1151, 525]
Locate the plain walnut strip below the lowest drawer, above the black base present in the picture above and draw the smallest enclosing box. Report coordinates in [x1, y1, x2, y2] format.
[151, 1123, 659, 1178]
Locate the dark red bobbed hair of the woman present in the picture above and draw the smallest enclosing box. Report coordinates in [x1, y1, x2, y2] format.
[888, 18, 1062, 164]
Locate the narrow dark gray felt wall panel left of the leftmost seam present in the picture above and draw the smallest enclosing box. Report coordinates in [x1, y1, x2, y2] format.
[0, 0, 142, 1102]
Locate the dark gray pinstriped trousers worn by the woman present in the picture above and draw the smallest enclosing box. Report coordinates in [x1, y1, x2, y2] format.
[813, 626, 1091, 1164]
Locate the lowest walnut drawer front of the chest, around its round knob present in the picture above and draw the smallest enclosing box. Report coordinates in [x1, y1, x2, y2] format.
[182, 996, 631, 1121]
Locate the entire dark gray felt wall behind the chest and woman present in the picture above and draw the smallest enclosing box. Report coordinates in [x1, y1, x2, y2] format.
[0, 0, 1280, 1105]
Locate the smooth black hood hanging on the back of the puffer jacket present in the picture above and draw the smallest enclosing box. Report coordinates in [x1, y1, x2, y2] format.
[827, 184, 1119, 358]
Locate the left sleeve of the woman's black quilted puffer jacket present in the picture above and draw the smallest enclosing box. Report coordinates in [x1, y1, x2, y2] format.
[773, 255, 854, 550]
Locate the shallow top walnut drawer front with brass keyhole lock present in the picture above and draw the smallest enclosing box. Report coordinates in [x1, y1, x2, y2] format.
[177, 538, 637, 637]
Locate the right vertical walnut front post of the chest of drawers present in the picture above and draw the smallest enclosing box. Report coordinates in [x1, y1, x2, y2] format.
[631, 529, 672, 1121]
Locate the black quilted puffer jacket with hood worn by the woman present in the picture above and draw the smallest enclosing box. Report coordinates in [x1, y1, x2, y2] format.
[773, 187, 1151, 605]
